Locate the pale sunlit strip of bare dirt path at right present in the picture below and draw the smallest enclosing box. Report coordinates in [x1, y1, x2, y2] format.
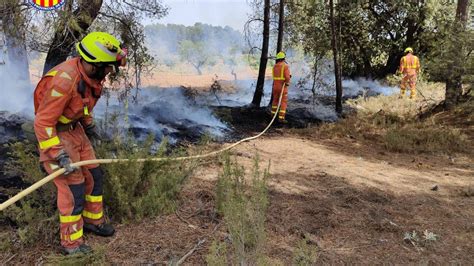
[231, 137, 474, 197]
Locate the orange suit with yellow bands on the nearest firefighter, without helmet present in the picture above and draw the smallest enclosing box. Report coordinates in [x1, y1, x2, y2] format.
[34, 58, 104, 248]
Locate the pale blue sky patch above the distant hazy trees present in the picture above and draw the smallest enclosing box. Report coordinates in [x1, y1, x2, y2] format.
[153, 0, 251, 31]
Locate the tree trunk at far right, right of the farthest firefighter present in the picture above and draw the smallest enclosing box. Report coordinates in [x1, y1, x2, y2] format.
[444, 0, 469, 109]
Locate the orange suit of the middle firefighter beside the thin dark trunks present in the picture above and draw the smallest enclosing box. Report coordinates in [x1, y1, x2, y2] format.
[272, 60, 291, 120]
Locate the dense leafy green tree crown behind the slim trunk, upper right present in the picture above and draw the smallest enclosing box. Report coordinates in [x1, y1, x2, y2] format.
[285, 0, 436, 78]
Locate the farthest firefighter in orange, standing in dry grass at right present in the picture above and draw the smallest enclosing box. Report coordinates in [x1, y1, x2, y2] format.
[399, 47, 420, 99]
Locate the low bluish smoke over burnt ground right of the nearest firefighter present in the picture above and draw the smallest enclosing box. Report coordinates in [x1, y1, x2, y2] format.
[94, 87, 229, 144]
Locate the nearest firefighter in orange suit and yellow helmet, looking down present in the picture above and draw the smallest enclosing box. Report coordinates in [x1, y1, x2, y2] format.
[34, 32, 127, 255]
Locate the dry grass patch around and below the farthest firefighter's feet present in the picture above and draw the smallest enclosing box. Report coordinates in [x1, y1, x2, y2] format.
[306, 82, 474, 154]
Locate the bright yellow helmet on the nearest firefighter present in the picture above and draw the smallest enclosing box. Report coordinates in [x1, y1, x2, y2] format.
[76, 32, 127, 63]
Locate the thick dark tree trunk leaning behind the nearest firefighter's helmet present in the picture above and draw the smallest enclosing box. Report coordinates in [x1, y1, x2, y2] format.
[43, 0, 103, 75]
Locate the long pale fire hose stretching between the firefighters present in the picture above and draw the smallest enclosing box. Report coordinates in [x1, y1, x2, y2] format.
[0, 84, 285, 211]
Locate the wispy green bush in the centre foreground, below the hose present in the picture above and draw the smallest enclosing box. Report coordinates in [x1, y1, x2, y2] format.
[212, 155, 268, 265]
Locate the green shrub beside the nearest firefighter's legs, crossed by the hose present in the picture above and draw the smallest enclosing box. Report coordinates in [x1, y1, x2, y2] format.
[97, 137, 196, 222]
